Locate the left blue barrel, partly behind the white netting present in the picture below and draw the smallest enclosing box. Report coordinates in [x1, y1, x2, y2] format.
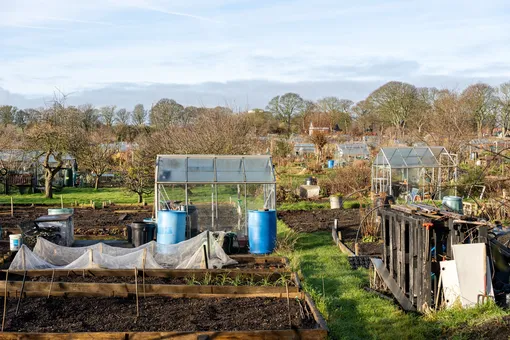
[156, 210, 186, 244]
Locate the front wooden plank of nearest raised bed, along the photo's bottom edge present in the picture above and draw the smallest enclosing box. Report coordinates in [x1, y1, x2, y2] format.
[2, 328, 328, 340]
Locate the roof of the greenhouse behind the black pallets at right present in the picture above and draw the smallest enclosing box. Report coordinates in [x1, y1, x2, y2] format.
[374, 146, 449, 168]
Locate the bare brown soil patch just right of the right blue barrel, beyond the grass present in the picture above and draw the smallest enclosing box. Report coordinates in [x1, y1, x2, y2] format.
[278, 209, 360, 238]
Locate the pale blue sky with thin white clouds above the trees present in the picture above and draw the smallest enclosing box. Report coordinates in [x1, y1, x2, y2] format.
[0, 0, 510, 109]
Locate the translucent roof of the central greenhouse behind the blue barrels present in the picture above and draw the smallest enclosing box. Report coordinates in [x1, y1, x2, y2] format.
[156, 155, 276, 184]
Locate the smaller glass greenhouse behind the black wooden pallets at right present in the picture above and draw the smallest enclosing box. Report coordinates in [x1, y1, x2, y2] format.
[372, 146, 458, 201]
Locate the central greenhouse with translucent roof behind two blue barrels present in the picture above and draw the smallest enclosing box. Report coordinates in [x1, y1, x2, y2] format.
[154, 155, 276, 238]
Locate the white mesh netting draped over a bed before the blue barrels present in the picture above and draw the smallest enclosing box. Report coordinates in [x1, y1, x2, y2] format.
[9, 231, 237, 270]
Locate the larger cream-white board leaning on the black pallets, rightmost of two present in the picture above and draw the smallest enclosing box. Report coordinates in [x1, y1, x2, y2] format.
[452, 243, 488, 307]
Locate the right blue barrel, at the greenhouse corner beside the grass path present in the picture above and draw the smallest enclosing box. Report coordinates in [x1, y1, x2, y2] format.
[248, 210, 276, 254]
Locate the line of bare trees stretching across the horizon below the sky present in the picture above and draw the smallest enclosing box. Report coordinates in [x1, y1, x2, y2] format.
[0, 81, 510, 197]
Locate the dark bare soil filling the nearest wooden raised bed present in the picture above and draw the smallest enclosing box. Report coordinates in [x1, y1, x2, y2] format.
[5, 297, 317, 333]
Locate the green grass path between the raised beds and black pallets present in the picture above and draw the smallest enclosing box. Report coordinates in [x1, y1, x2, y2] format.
[278, 221, 508, 339]
